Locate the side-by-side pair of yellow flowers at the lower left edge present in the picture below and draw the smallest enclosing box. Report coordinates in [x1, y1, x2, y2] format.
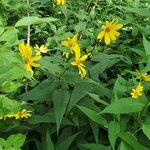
[0, 109, 32, 120]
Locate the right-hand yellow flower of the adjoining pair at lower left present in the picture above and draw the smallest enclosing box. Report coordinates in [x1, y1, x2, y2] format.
[14, 109, 32, 119]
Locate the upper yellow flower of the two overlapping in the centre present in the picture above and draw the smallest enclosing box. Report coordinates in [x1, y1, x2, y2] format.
[61, 34, 80, 59]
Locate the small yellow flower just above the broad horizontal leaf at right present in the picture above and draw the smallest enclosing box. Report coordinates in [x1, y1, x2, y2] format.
[130, 82, 143, 99]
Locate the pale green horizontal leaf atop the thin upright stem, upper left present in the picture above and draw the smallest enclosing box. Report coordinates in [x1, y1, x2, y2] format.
[15, 16, 58, 27]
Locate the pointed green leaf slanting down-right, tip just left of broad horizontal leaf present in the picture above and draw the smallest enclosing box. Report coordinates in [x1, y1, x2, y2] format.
[77, 106, 108, 126]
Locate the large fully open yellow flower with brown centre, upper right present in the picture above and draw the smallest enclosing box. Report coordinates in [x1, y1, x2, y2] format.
[97, 19, 123, 45]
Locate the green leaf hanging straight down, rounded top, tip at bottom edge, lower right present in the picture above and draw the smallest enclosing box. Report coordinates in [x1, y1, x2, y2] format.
[108, 121, 120, 150]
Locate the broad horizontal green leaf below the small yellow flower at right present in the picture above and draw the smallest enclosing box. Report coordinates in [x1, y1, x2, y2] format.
[100, 98, 144, 114]
